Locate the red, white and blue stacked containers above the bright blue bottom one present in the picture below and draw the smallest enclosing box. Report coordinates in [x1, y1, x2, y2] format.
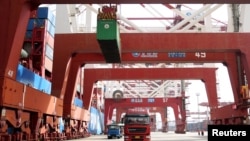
[24, 7, 55, 79]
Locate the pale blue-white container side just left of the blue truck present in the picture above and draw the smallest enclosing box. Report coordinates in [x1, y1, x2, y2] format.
[88, 107, 103, 134]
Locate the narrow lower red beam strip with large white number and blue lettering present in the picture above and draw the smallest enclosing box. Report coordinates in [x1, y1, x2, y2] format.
[73, 50, 236, 65]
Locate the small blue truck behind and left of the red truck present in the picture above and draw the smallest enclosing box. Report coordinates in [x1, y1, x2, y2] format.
[107, 123, 123, 139]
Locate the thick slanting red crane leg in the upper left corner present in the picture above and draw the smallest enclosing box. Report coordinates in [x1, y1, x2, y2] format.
[0, 0, 33, 80]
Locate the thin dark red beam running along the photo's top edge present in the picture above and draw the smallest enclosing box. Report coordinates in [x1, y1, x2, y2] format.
[36, 0, 250, 4]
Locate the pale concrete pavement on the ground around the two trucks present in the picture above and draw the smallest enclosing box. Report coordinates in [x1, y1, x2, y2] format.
[67, 132, 207, 141]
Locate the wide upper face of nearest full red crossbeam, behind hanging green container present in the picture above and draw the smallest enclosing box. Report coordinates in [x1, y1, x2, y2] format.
[55, 33, 250, 53]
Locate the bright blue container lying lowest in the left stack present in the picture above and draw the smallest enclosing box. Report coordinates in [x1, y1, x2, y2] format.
[16, 64, 51, 94]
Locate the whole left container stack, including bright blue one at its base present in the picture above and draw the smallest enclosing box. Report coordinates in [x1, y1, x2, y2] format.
[16, 7, 55, 94]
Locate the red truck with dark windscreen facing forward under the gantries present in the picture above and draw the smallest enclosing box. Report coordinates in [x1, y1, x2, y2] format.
[122, 109, 151, 141]
